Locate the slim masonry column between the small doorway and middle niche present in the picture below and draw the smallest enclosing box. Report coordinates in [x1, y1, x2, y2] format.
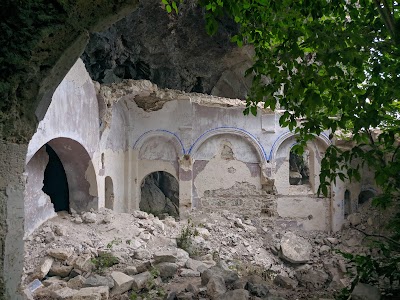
[179, 154, 193, 219]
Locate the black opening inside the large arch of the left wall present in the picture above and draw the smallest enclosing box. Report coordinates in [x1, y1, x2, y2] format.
[42, 144, 69, 212]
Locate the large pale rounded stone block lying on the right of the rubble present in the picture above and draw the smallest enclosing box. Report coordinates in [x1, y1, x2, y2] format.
[280, 232, 312, 264]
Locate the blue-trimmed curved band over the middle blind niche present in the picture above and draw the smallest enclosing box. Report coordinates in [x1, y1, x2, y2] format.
[187, 127, 267, 163]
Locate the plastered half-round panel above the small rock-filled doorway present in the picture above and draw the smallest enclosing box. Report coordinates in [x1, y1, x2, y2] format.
[133, 129, 186, 161]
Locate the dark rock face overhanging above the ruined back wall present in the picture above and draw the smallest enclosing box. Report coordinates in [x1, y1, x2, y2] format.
[82, 0, 250, 98]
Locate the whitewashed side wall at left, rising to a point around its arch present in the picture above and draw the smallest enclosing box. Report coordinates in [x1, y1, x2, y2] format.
[24, 59, 99, 234]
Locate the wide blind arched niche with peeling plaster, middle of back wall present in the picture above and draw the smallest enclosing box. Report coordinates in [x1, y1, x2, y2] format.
[191, 130, 264, 212]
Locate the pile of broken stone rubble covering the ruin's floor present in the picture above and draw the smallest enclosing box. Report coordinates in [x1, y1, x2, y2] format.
[24, 208, 379, 300]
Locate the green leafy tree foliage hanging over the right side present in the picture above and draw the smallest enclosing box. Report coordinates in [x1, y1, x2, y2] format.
[162, 0, 400, 296]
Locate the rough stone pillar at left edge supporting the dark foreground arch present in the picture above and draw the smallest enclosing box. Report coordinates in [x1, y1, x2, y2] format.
[0, 141, 28, 300]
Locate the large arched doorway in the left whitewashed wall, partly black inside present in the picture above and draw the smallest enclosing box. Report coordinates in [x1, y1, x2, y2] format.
[24, 138, 98, 234]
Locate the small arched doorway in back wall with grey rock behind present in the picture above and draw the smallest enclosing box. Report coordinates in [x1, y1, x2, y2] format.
[139, 171, 179, 218]
